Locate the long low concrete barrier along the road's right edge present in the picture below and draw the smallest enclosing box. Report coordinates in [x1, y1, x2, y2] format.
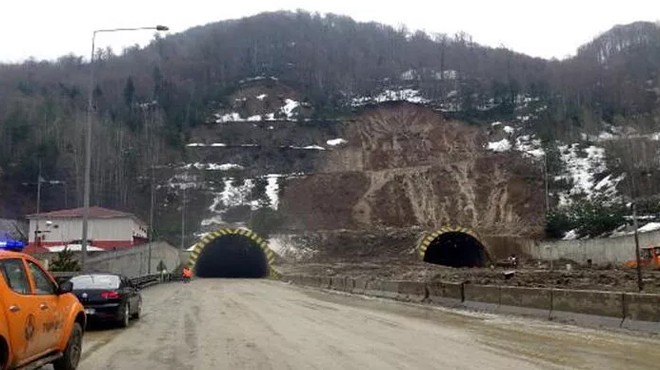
[282, 276, 660, 333]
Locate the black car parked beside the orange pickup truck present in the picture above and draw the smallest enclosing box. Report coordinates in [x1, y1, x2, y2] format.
[70, 274, 142, 327]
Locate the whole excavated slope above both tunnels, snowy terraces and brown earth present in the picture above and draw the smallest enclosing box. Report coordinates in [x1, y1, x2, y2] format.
[168, 80, 544, 260]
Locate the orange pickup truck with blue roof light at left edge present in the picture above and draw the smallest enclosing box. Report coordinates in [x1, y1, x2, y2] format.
[0, 242, 86, 370]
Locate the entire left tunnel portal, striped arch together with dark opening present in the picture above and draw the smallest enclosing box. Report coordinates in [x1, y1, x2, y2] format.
[187, 228, 277, 278]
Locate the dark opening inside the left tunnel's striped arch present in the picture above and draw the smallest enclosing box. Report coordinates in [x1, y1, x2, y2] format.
[195, 234, 268, 278]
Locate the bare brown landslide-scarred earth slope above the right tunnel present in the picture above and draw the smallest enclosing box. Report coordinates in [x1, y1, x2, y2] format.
[282, 103, 543, 236]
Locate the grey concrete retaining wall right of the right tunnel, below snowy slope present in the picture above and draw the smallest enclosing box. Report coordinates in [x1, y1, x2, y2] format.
[528, 230, 660, 265]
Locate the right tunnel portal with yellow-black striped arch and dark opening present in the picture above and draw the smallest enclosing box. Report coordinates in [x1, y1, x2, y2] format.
[417, 226, 491, 267]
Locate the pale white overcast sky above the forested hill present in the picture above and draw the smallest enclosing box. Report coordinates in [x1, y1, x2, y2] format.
[0, 0, 660, 62]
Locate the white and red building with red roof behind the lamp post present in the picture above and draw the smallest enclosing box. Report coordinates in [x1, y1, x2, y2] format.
[26, 207, 148, 253]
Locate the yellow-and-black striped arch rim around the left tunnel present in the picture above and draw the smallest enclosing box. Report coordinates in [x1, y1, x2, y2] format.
[186, 228, 279, 279]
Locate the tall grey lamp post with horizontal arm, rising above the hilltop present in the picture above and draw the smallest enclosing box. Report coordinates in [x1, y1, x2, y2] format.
[80, 25, 169, 271]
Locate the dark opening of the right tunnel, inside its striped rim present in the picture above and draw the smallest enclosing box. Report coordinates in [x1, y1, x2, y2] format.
[424, 232, 487, 267]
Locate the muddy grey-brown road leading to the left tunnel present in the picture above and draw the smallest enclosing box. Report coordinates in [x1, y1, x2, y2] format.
[73, 279, 660, 370]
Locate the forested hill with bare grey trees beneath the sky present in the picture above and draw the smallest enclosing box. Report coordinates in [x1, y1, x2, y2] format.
[0, 12, 660, 217]
